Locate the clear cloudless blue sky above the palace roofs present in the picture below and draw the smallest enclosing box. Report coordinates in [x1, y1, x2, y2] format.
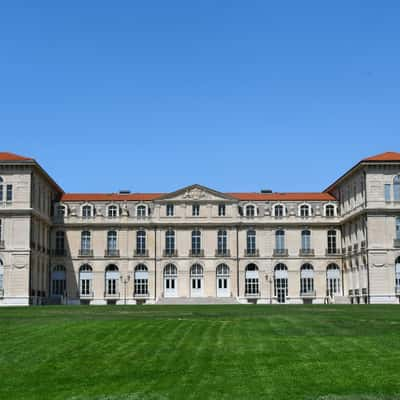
[0, 0, 400, 192]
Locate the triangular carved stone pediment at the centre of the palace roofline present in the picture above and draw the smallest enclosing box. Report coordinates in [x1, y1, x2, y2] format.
[157, 184, 237, 202]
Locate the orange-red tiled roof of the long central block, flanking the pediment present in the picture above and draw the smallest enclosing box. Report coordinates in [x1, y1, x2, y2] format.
[61, 193, 335, 201]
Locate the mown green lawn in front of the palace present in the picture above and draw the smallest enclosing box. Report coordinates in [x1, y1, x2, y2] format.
[0, 305, 400, 400]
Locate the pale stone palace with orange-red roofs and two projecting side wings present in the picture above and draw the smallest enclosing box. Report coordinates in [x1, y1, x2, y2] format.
[0, 152, 400, 306]
